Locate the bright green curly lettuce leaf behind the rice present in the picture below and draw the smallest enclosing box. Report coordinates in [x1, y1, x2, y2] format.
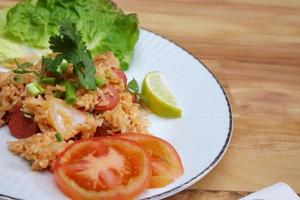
[0, 0, 139, 70]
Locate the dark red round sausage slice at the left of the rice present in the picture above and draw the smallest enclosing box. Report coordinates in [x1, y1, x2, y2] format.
[8, 110, 39, 139]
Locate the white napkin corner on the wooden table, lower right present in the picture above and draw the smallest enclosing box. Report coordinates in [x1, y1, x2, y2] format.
[240, 182, 300, 200]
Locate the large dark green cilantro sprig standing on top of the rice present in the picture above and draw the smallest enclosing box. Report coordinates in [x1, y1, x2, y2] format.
[49, 20, 96, 90]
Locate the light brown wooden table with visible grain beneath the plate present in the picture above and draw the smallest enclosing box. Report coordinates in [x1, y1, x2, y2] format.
[0, 0, 300, 200]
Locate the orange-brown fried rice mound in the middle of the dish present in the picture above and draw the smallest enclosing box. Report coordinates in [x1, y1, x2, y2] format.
[0, 52, 149, 170]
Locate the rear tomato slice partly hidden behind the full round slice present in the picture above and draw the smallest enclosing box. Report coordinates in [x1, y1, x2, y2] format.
[117, 133, 184, 188]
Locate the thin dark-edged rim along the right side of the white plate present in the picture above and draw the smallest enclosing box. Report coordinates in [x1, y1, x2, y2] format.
[140, 27, 233, 200]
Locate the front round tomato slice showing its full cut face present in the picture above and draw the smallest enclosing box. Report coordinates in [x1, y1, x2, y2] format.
[54, 137, 151, 200]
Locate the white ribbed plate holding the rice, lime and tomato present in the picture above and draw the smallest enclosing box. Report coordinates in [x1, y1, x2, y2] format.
[0, 30, 232, 200]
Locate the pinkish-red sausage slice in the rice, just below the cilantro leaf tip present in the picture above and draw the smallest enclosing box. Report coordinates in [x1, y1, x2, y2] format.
[95, 84, 119, 112]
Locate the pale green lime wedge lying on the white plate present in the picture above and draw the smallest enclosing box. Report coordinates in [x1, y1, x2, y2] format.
[142, 72, 181, 118]
